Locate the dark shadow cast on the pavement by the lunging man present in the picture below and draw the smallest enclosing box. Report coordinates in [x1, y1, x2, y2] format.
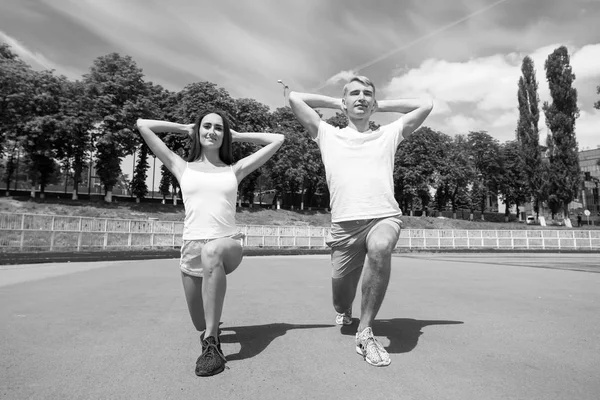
[341, 318, 464, 354]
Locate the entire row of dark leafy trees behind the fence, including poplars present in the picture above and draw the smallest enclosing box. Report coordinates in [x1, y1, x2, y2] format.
[0, 44, 600, 219]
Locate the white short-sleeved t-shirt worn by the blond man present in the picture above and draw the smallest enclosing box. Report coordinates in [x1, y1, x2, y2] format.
[314, 118, 404, 222]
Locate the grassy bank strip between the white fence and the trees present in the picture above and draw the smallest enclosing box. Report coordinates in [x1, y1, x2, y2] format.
[0, 197, 600, 230]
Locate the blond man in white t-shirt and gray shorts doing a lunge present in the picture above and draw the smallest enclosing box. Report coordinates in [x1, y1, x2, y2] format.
[289, 76, 433, 366]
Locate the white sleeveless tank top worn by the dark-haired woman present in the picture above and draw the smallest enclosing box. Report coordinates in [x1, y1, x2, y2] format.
[179, 163, 238, 240]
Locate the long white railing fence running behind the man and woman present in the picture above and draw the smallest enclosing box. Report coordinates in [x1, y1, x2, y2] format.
[0, 213, 600, 252]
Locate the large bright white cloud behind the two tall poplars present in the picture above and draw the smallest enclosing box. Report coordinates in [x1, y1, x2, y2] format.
[382, 44, 600, 146]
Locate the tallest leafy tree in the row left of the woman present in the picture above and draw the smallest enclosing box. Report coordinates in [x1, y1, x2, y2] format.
[84, 53, 147, 202]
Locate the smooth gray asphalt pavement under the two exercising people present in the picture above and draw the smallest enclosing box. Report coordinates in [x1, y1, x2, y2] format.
[0, 253, 600, 400]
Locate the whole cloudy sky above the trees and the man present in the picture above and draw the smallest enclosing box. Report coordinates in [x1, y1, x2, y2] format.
[0, 0, 600, 175]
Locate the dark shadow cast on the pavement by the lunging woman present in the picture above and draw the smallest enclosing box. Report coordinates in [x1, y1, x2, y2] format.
[219, 323, 333, 361]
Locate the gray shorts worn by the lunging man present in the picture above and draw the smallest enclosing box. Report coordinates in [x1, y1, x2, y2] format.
[326, 214, 402, 278]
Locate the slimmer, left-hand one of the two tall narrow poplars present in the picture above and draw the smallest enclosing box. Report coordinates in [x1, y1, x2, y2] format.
[511, 56, 544, 216]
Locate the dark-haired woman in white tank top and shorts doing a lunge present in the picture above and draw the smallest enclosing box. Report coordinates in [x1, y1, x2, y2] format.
[137, 112, 284, 376]
